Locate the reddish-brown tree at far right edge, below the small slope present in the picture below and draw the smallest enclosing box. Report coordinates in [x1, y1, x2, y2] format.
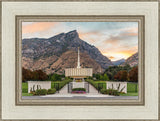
[129, 66, 138, 82]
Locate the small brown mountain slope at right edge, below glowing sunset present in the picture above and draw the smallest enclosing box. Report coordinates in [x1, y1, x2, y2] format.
[122, 52, 138, 67]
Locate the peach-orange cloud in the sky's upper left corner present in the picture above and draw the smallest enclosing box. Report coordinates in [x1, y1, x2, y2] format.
[22, 22, 58, 34]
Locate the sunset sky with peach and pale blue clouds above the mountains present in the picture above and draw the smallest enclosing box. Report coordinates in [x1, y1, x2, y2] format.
[22, 22, 138, 61]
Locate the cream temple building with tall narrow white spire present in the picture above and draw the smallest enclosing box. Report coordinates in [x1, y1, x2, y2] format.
[65, 48, 93, 81]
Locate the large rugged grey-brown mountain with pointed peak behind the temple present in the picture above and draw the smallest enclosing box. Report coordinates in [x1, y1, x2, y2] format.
[22, 30, 113, 74]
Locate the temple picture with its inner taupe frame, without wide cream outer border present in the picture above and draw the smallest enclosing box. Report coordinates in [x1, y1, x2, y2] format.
[16, 16, 144, 105]
